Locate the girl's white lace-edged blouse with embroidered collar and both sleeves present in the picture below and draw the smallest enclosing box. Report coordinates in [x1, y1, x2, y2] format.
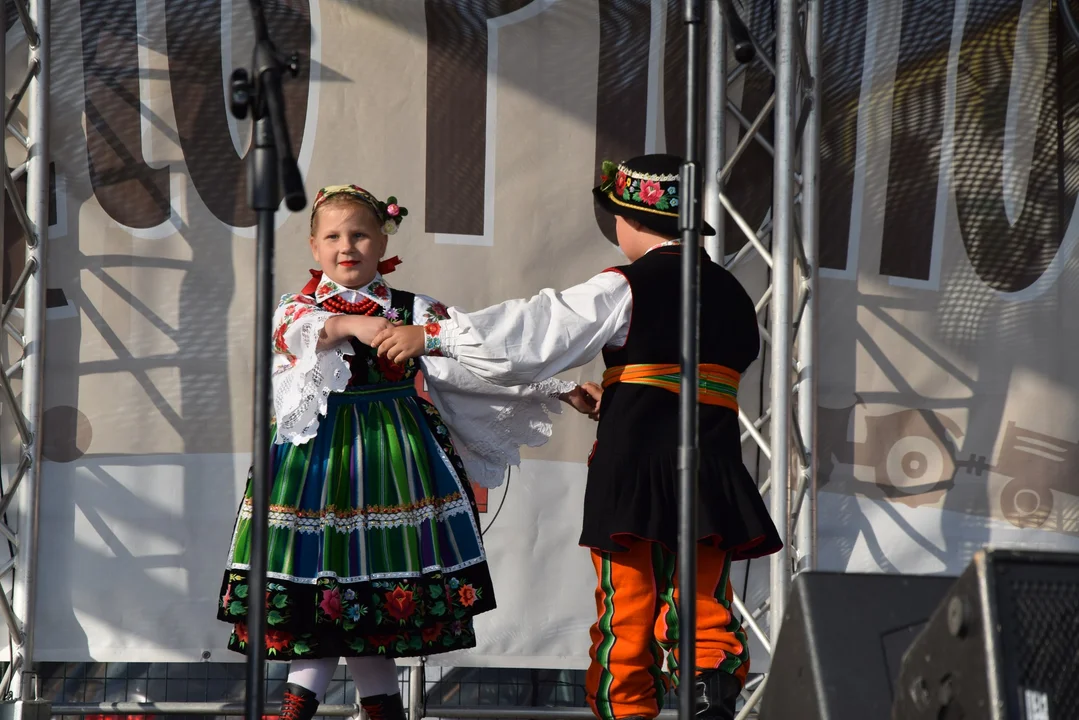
[266, 275, 576, 488]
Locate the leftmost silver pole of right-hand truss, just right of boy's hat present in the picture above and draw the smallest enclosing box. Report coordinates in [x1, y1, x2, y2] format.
[704, 0, 727, 263]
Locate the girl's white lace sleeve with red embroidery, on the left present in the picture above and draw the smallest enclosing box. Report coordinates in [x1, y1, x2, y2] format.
[272, 295, 353, 445]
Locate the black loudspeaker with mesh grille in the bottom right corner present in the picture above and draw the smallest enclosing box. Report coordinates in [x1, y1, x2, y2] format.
[892, 551, 1079, 720]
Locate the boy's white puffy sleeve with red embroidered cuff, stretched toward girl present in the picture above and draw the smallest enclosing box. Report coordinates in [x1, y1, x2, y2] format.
[424, 271, 633, 385]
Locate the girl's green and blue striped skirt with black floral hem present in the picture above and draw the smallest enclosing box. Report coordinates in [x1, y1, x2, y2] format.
[218, 381, 495, 661]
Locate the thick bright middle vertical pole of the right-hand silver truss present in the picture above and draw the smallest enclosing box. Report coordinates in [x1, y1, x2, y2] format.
[768, 0, 797, 647]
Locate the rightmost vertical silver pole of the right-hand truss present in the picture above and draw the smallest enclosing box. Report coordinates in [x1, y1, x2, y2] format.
[795, 0, 822, 572]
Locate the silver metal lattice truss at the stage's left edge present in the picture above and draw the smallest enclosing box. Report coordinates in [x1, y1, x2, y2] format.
[0, 0, 50, 701]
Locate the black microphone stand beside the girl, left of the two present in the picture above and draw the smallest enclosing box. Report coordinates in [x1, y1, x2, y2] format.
[231, 0, 308, 720]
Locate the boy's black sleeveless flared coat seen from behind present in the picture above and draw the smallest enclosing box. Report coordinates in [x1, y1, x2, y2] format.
[581, 245, 778, 558]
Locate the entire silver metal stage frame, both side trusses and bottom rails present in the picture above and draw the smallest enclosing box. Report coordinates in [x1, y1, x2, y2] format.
[0, 0, 822, 718]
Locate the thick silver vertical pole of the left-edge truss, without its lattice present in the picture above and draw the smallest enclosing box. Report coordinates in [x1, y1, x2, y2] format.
[11, 0, 50, 699]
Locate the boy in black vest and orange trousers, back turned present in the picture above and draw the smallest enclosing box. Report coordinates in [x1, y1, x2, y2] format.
[372, 154, 781, 720]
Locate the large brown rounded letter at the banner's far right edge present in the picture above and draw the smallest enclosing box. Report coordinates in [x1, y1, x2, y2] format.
[953, 0, 1079, 293]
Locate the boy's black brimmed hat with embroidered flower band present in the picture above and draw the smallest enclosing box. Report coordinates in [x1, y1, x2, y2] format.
[592, 154, 715, 237]
